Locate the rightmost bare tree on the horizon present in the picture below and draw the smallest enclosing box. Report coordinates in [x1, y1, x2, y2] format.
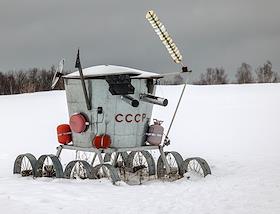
[256, 61, 279, 83]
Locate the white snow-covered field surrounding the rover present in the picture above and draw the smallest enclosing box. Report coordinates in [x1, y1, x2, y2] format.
[0, 84, 280, 214]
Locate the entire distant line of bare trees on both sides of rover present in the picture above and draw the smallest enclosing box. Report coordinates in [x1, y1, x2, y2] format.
[0, 61, 280, 95]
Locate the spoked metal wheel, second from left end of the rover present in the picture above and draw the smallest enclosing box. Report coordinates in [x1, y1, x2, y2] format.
[35, 155, 63, 178]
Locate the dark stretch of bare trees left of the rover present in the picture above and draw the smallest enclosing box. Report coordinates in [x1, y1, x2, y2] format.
[0, 66, 68, 95]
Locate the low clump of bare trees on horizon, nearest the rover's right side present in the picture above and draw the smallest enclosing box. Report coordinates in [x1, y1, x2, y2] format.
[196, 67, 228, 85]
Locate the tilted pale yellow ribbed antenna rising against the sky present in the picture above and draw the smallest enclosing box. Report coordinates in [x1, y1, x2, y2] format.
[146, 10, 184, 67]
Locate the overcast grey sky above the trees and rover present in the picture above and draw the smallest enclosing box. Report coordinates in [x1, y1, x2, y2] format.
[0, 0, 280, 80]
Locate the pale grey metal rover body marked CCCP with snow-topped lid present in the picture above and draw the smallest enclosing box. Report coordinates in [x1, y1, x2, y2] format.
[63, 65, 160, 148]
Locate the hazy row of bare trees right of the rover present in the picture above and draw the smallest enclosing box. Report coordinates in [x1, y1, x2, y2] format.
[194, 61, 280, 85]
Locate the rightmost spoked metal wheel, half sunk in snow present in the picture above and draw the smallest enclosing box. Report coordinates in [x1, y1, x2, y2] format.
[184, 157, 211, 177]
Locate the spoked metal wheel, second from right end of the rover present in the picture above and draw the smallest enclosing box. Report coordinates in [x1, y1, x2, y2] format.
[157, 151, 185, 181]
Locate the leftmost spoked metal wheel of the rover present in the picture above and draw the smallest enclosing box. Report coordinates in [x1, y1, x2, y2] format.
[13, 153, 37, 177]
